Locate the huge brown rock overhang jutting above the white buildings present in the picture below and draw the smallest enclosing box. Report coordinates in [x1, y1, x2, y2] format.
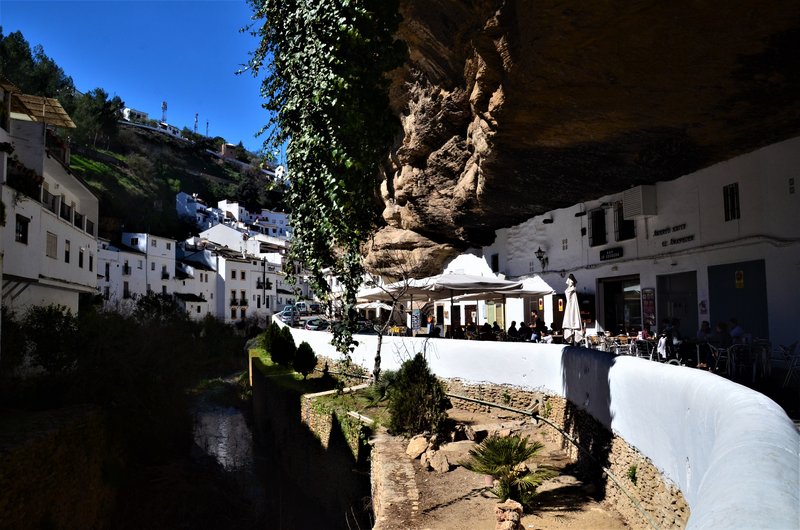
[368, 0, 800, 276]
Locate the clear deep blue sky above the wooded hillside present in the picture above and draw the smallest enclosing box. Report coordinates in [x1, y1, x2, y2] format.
[0, 0, 268, 155]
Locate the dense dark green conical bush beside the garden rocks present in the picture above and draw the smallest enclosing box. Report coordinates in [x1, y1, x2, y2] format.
[389, 353, 451, 435]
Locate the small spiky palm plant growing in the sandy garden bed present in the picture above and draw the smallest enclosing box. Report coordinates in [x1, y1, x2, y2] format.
[460, 434, 556, 508]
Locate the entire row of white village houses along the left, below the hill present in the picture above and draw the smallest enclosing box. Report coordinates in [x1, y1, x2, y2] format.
[0, 82, 318, 327]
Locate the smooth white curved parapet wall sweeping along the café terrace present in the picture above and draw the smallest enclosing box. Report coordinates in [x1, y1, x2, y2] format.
[282, 318, 800, 528]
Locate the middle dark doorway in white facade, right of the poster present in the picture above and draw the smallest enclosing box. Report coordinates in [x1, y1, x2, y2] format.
[655, 271, 697, 339]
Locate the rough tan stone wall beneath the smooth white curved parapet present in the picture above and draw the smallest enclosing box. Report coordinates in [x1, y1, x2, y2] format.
[444, 380, 689, 528]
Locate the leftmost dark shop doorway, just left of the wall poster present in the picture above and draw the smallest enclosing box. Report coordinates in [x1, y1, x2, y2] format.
[599, 274, 642, 335]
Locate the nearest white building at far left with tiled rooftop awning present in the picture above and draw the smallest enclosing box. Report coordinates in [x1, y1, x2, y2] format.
[0, 83, 98, 312]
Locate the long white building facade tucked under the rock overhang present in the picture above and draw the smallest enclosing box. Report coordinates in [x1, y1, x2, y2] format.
[472, 134, 800, 344]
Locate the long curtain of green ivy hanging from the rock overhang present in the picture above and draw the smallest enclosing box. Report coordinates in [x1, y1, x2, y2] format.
[247, 0, 406, 354]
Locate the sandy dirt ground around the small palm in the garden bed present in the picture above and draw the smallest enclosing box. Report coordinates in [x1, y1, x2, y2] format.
[399, 409, 628, 530]
